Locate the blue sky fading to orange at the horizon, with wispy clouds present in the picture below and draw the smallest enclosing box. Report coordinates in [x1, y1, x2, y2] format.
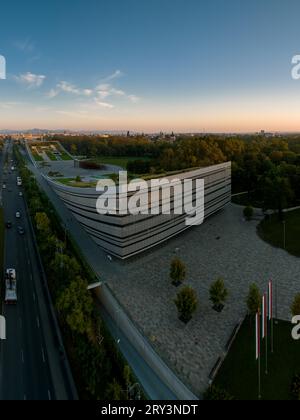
[0, 0, 300, 131]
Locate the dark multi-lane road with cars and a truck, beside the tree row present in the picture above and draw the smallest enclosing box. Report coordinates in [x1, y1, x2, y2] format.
[0, 144, 72, 400]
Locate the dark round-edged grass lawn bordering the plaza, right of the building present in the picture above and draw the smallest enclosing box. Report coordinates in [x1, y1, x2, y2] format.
[257, 210, 300, 257]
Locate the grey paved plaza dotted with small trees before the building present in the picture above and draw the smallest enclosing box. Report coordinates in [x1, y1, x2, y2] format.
[109, 205, 300, 395]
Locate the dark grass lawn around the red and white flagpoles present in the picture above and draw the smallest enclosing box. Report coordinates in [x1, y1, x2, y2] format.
[214, 319, 300, 400]
